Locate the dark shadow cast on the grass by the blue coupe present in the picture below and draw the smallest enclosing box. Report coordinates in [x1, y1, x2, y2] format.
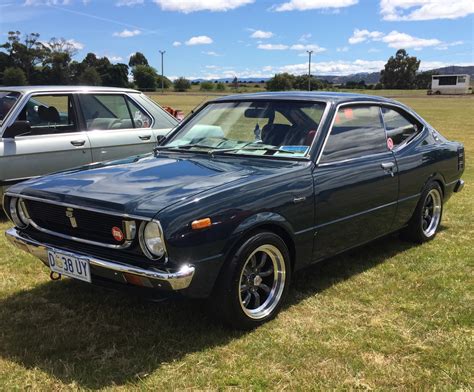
[0, 231, 422, 388]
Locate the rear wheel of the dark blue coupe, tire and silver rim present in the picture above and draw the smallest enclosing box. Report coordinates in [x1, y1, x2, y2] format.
[401, 182, 443, 244]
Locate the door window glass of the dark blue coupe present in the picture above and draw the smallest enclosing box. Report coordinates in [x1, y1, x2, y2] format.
[321, 105, 387, 163]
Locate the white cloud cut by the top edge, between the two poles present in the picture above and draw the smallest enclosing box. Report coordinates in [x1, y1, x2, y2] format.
[153, 0, 255, 14]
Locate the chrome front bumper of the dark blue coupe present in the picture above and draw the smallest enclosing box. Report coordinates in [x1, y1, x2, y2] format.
[5, 228, 195, 290]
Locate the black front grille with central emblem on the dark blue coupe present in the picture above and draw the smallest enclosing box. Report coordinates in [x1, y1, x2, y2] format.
[24, 199, 133, 247]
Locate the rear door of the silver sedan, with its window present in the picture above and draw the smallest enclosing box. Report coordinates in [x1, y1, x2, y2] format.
[78, 93, 156, 162]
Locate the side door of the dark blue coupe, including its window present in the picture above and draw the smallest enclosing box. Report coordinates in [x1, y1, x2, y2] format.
[313, 104, 398, 260]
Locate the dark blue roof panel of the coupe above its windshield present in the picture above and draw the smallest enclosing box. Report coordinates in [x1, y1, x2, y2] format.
[212, 91, 400, 104]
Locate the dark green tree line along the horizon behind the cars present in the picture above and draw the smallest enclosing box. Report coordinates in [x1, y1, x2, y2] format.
[0, 31, 433, 91]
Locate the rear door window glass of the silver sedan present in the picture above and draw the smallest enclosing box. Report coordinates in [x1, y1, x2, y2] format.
[79, 94, 151, 130]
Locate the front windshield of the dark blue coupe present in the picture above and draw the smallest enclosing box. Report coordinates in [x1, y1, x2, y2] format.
[161, 100, 325, 158]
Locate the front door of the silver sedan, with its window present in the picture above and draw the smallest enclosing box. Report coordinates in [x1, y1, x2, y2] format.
[0, 94, 92, 186]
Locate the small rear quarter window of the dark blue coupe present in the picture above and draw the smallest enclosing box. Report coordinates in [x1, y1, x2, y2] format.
[382, 107, 422, 148]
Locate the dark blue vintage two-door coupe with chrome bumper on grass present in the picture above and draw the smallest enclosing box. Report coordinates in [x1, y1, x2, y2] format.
[3, 92, 465, 328]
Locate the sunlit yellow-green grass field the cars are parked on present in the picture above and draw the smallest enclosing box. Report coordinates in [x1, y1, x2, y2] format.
[0, 94, 474, 391]
